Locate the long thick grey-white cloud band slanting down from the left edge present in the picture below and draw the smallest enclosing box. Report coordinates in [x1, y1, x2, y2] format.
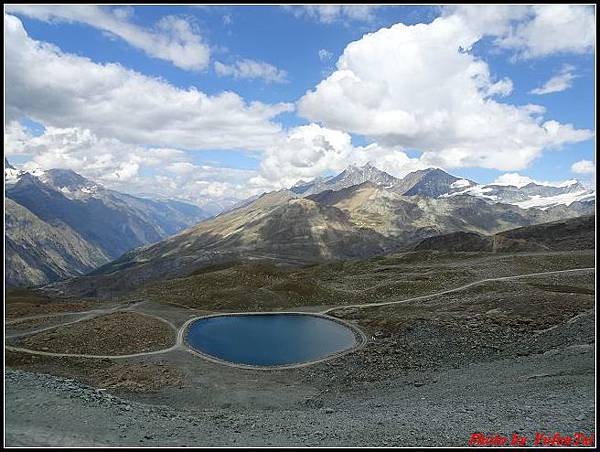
[5, 15, 292, 150]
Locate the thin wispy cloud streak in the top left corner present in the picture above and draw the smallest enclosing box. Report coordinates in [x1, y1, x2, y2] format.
[6, 5, 210, 70]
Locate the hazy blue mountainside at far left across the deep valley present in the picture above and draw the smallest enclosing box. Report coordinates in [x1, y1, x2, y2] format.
[5, 162, 208, 284]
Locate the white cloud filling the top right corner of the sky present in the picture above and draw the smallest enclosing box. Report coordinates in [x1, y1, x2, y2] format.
[445, 5, 596, 58]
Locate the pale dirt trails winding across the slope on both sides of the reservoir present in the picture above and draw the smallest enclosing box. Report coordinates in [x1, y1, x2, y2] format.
[4, 267, 596, 359]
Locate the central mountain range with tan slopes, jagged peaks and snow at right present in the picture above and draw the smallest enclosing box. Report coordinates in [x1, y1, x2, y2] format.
[41, 165, 595, 298]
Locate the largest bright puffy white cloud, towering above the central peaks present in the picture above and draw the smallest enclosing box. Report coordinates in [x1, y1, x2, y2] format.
[298, 15, 593, 170]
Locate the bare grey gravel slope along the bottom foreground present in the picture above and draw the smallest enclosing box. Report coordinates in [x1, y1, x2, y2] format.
[5, 340, 594, 446]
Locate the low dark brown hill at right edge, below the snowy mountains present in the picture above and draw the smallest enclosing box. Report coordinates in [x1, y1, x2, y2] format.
[414, 215, 596, 252]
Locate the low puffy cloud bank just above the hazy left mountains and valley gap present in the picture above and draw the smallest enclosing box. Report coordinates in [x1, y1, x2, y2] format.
[4, 122, 265, 205]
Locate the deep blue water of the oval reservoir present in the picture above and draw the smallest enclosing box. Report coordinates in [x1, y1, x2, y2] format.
[186, 314, 357, 366]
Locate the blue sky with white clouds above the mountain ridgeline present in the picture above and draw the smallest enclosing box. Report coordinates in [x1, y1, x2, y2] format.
[4, 5, 596, 205]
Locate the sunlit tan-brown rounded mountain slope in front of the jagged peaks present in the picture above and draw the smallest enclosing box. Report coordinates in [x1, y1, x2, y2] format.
[54, 190, 397, 297]
